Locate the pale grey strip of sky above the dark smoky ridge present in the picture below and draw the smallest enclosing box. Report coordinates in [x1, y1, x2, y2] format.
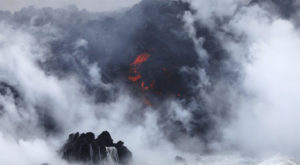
[0, 0, 140, 11]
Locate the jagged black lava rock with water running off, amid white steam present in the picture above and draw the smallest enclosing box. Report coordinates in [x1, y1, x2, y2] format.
[61, 131, 132, 165]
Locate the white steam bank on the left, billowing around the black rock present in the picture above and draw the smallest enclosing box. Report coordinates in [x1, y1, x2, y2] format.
[0, 24, 197, 165]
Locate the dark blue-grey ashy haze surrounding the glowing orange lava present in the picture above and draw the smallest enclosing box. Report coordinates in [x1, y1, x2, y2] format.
[0, 1, 234, 142]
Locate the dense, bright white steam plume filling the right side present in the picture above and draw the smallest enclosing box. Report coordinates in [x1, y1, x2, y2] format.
[189, 0, 300, 159]
